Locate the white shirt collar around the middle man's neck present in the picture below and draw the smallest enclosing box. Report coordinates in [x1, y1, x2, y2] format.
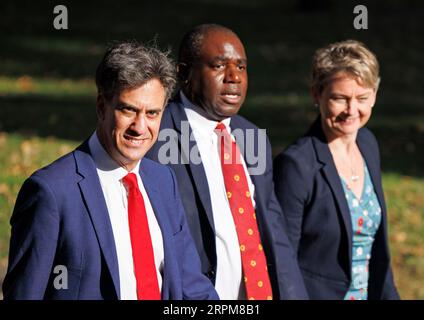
[180, 91, 231, 135]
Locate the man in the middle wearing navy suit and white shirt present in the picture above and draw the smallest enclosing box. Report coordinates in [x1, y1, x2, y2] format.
[146, 24, 307, 300]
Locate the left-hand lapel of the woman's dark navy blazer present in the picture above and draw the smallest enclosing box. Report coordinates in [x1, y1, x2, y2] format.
[310, 119, 353, 273]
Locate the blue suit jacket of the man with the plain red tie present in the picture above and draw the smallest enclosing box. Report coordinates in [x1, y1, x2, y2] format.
[3, 141, 218, 299]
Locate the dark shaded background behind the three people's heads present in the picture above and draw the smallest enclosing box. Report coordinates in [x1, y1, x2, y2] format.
[0, 0, 424, 176]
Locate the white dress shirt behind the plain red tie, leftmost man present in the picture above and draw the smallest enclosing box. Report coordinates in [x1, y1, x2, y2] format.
[88, 132, 164, 300]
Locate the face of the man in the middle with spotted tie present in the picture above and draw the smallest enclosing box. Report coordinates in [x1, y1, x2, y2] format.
[185, 30, 247, 121]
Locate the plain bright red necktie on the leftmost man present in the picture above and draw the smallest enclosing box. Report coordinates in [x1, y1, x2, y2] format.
[123, 173, 160, 300]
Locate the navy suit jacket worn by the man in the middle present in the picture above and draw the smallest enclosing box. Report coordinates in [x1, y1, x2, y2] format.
[146, 95, 307, 299]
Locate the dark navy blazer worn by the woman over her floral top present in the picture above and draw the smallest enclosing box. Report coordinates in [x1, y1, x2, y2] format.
[274, 118, 399, 299]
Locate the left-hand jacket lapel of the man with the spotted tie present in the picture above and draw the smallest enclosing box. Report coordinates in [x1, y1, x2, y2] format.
[170, 101, 215, 229]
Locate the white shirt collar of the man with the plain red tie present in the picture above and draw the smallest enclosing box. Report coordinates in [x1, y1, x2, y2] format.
[88, 131, 140, 180]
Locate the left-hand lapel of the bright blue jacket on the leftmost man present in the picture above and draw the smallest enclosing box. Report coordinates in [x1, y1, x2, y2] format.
[75, 141, 120, 299]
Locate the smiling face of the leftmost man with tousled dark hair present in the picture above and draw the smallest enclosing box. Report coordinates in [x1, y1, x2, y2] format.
[97, 79, 166, 171]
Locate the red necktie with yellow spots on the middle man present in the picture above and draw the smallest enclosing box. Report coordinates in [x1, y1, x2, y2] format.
[215, 123, 272, 300]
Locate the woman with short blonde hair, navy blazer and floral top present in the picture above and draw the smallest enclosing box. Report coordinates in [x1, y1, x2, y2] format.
[274, 40, 399, 300]
